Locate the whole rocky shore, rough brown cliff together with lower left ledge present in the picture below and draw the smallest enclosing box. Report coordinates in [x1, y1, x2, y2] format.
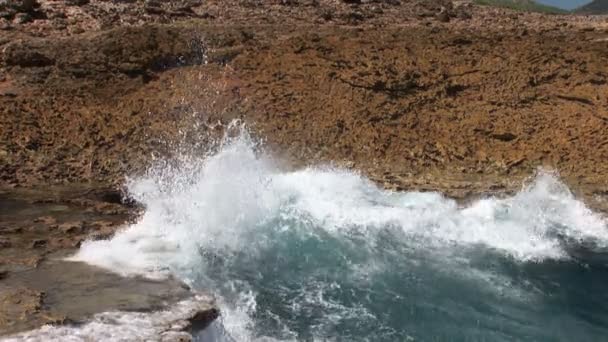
[0, 0, 608, 335]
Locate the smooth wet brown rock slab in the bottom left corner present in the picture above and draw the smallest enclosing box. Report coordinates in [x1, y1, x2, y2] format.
[0, 260, 218, 340]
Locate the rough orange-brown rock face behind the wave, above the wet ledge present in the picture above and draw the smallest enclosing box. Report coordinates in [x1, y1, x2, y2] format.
[0, 0, 608, 206]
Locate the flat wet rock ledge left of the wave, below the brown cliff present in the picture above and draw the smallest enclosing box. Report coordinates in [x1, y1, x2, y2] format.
[0, 187, 218, 341]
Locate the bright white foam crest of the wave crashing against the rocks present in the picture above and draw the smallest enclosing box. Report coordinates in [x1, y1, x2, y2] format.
[73, 129, 608, 340]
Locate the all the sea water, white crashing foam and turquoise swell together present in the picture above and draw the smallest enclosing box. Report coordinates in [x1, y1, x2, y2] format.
[67, 133, 608, 341]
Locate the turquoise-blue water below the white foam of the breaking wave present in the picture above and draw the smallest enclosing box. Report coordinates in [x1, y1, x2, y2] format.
[198, 224, 608, 341]
